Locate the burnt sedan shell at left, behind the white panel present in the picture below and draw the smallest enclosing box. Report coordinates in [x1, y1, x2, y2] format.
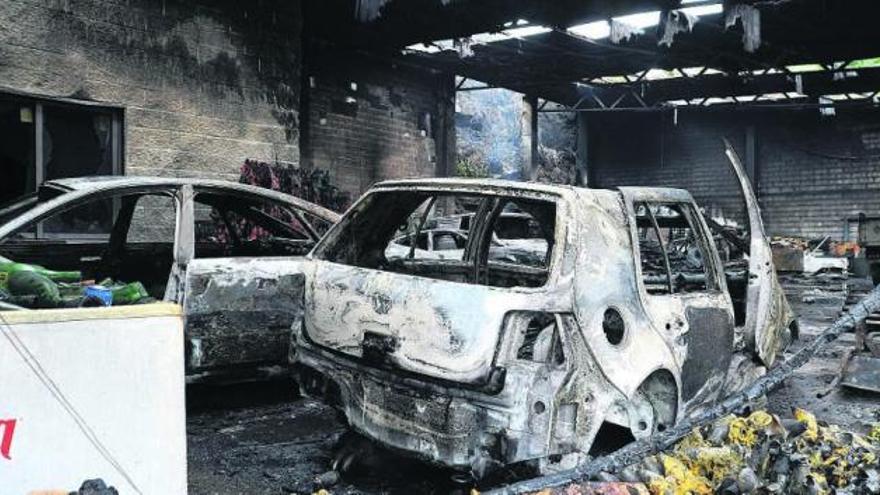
[0, 177, 338, 381]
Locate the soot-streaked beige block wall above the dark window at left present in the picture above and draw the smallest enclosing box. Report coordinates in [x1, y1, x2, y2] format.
[0, 0, 301, 180]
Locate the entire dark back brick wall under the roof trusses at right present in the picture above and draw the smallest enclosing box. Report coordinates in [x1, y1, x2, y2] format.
[588, 110, 880, 238]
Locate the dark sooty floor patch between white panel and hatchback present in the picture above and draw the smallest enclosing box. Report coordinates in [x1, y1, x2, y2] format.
[187, 384, 453, 495]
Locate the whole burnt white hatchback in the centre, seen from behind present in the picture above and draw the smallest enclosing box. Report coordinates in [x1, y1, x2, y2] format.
[291, 147, 796, 476]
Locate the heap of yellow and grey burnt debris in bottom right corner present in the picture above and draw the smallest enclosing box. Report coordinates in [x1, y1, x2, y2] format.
[599, 409, 880, 495]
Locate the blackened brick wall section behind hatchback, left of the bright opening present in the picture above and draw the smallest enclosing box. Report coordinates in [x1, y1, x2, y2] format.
[303, 48, 455, 196]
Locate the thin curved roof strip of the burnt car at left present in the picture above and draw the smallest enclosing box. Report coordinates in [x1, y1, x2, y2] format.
[40, 175, 339, 222]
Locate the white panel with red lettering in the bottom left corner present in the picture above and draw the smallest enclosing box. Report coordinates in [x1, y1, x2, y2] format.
[0, 305, 187, 494]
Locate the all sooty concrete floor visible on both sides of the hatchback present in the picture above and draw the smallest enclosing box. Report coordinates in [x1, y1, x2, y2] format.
[187, 275, 880, 495]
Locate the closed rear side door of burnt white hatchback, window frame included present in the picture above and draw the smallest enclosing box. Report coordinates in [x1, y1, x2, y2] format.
[631, 195, 734, 413]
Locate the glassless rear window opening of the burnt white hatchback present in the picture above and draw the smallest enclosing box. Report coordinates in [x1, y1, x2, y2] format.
[316, 191, 556, 287]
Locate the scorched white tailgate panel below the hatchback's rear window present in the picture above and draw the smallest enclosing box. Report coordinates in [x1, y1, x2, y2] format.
[305, 261, 529, 385]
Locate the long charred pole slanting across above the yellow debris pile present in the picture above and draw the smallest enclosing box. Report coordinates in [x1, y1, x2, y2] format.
[486, 287, 880, 495]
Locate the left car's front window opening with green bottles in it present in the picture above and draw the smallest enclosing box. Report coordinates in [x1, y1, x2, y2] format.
[0, 192, 177, 309]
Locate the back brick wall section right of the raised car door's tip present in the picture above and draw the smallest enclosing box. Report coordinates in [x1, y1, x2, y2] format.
[758, 111, 880, 238]
